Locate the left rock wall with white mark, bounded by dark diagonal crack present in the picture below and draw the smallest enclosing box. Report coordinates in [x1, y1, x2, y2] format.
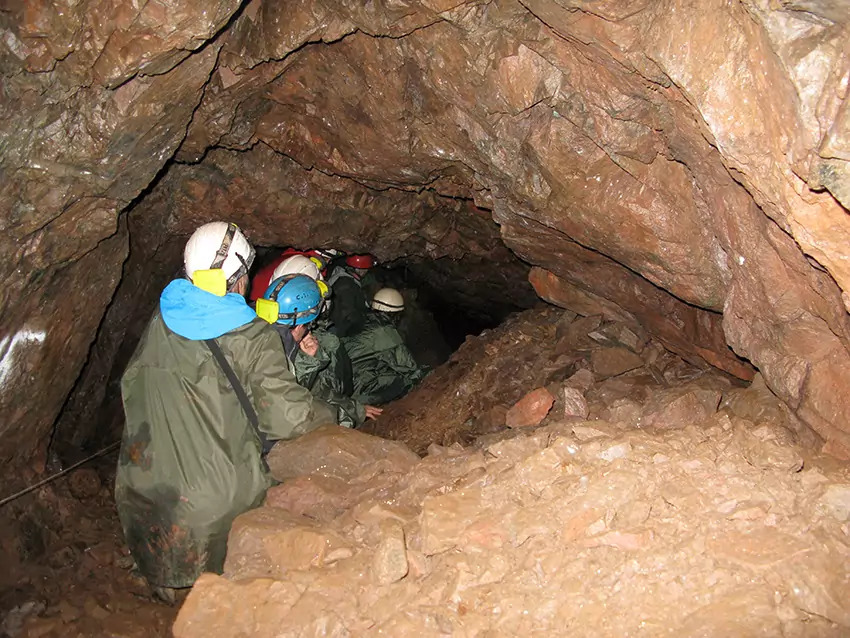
[0, 0, 238, 480]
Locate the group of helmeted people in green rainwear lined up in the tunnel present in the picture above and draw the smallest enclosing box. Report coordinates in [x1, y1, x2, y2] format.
[115, 222, 426, 601]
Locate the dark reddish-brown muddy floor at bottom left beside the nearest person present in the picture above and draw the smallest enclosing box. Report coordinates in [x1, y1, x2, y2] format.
[0, 464, 178, 638]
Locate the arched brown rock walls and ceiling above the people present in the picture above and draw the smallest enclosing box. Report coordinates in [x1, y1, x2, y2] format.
[0, 0, 850, 480]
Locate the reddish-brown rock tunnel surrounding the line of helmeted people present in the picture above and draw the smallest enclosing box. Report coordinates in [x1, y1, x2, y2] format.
[0, 0, 850, 638]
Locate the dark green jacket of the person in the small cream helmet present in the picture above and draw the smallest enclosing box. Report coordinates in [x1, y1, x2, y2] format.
[342, 311, 426, 405]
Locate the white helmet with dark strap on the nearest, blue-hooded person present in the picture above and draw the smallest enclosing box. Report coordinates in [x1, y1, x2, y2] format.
[183, 222, 254, 290]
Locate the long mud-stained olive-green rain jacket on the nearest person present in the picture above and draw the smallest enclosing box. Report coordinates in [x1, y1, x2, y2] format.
[115, 280, 336, 587]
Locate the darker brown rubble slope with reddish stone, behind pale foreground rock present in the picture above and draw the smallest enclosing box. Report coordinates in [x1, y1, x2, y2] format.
[364, 307, 752, 454]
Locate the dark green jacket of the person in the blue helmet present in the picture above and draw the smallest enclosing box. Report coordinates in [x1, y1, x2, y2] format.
[294, 328, 366, 428]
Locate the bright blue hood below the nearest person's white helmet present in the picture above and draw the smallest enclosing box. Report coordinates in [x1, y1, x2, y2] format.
[159, 279, 257, 341]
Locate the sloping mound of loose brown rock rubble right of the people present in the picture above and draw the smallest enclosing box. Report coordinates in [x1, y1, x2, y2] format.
[174, 312, 850, 638]
